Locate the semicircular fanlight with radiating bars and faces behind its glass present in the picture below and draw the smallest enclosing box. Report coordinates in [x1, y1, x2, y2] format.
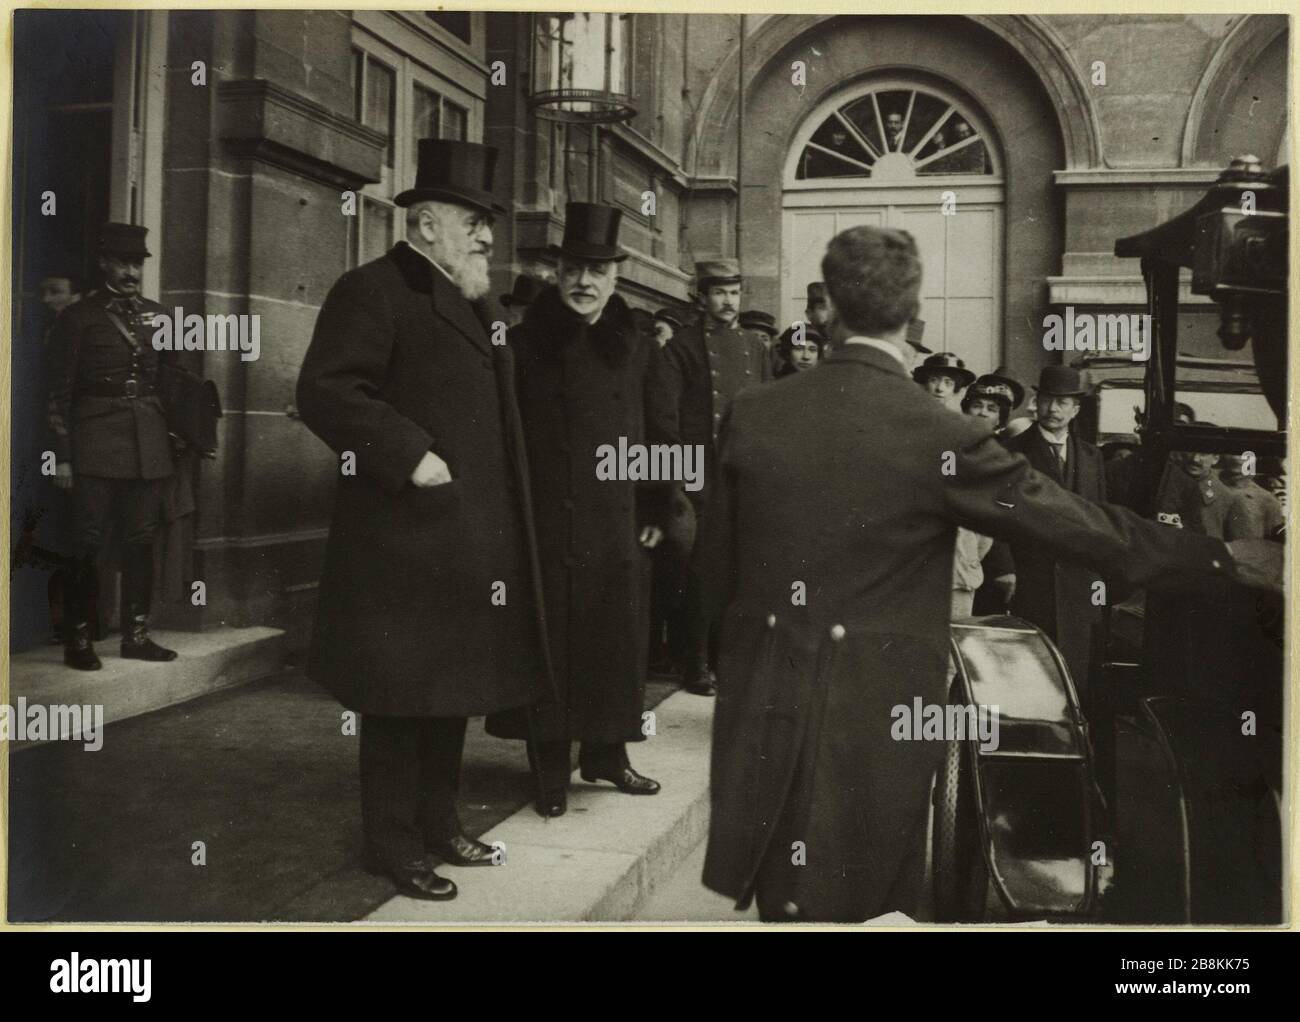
[794, 87, 998, 182]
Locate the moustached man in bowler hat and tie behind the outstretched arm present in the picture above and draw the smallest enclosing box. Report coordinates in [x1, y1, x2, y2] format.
[1004, 365, 1106, 693]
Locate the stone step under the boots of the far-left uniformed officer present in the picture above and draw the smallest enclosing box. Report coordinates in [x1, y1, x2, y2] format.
[8, 628, 285, 752]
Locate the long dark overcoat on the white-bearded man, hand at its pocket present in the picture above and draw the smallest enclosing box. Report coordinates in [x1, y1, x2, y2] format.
[298, 243, 545, 716]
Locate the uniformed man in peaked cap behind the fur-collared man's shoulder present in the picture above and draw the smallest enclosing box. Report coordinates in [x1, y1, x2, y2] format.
[664, 259, 772, 696]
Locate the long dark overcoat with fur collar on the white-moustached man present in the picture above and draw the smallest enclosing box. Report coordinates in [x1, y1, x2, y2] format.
[488, 286, 672, 742]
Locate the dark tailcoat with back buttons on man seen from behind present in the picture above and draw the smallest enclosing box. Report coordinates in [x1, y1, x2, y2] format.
[694, 345, 1231, 921]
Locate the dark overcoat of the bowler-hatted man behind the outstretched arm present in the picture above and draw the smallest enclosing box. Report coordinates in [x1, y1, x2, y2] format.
[1002, 425, 1112, 690]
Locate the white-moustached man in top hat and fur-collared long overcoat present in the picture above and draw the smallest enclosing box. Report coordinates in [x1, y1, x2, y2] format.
[488, 203, 675, 817]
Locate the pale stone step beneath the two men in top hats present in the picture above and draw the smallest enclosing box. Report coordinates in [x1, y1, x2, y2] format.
[365, 692, 714, 924]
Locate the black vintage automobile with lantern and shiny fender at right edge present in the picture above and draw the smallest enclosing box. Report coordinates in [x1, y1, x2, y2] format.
[931, 157, 1288, 924]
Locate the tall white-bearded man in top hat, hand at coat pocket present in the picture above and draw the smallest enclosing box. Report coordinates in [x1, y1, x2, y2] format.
[298, 139, 546, 900]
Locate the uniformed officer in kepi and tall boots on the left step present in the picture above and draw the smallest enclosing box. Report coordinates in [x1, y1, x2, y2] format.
[49, 224, 176, 671]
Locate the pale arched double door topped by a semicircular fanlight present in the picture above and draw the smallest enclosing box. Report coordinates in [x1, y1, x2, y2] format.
[781, 75, 1005, 372]
